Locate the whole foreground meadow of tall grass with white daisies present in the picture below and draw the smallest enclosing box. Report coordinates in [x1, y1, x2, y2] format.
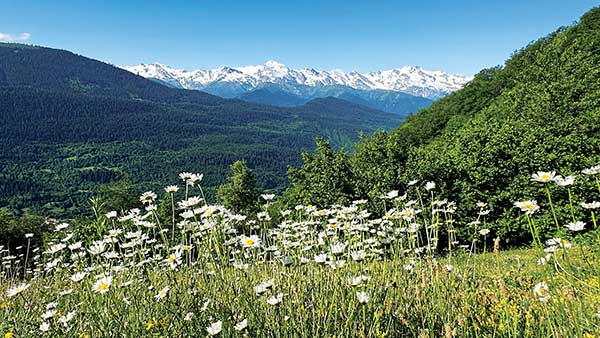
[0, 168, 600, 337]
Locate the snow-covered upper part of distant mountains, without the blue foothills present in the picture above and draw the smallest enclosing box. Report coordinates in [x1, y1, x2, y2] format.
[124, 61, 470, 100]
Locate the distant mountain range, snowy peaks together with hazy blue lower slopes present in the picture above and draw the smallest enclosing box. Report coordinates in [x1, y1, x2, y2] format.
[124, 61, 470, 116]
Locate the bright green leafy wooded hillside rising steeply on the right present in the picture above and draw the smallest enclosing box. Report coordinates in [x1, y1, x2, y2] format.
[286, 8, 600, 244]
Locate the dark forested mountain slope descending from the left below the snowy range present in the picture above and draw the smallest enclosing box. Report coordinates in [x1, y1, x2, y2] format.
[0, 44, 400, 216]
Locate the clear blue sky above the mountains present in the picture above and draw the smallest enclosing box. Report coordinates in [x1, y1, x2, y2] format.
[0, 0, 599, 75]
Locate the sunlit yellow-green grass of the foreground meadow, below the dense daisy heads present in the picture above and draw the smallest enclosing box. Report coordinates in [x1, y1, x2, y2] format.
[0, 248, 600, 337]
